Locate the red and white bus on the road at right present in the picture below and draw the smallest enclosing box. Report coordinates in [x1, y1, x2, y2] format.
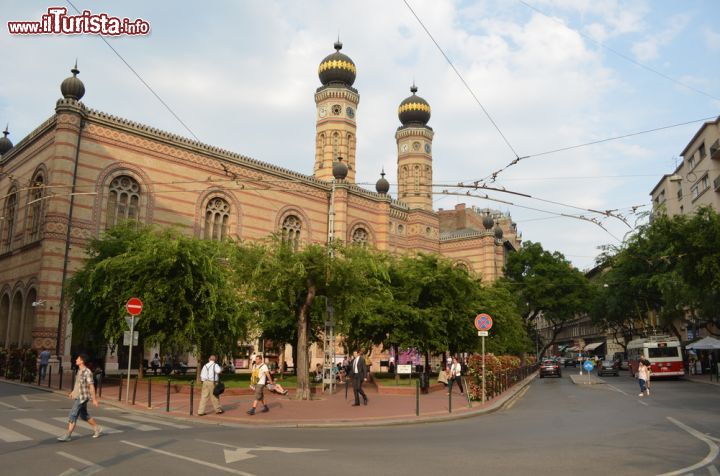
[627, 336, 685, 379]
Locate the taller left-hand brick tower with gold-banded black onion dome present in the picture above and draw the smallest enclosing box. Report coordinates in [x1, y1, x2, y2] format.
[313, 41, 360, 183]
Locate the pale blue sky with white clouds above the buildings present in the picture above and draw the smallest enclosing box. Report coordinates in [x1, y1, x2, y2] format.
[0, 0, 720, 269]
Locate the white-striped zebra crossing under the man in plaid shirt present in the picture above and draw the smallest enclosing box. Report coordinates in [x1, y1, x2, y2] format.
[0, 415, 191, 443]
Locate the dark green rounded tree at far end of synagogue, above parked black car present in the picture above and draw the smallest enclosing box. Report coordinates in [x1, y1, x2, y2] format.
[504, 241, 593, 355]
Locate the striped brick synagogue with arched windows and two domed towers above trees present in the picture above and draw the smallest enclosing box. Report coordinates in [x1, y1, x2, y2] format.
[0, 42, 520, 362]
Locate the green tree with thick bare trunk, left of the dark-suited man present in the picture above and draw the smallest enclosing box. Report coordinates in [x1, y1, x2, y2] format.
[247, 239, 394, 399]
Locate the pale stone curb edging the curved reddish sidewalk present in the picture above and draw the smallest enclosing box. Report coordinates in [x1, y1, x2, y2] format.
[3, 372, 537, 429]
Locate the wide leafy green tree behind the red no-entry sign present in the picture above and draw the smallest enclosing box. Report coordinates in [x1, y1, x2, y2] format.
[68, 223, 249, 368]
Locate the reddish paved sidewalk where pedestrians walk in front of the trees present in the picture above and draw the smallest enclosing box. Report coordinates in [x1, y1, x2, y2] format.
[8, 374, 535, 428]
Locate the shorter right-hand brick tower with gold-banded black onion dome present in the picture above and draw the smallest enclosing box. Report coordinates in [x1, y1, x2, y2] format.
[395, 84, 435, 211]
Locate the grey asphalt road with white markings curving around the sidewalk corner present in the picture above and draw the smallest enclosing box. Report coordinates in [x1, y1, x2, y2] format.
[0, 369, 720, 476]
